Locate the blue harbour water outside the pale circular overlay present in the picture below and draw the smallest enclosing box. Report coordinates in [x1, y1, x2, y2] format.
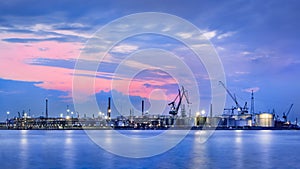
[0, 130, 300, 169]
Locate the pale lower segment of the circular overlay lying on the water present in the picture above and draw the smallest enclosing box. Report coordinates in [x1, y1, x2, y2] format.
[85, 130, 189, 158]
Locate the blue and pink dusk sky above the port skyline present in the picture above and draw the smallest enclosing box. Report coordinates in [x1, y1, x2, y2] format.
[0, 0, 300, 121]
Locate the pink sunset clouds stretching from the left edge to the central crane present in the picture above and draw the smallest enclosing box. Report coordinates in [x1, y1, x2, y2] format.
[0, 41, 177, 100]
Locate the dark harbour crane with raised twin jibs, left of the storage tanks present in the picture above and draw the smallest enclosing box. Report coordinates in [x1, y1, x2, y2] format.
[168, 86, 191, 116]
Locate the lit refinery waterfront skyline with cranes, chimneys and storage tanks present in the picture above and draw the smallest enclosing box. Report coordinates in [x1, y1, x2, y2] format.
[0, 81, 299, 130]
